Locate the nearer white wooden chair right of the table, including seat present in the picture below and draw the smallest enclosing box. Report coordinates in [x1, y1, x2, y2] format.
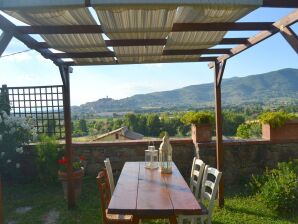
[179, 165, 222, 224]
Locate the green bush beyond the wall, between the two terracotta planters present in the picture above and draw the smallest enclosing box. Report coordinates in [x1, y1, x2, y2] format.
[236, 122, 262, 139]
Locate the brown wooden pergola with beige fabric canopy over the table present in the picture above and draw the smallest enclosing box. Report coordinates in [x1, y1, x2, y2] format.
[0, 0, 298, 210]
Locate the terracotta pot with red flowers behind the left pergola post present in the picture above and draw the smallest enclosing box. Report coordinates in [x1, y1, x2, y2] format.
[58, 156, 85, 198]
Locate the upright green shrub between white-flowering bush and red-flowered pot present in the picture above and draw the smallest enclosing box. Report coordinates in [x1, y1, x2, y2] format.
[36, 135, 62, 184]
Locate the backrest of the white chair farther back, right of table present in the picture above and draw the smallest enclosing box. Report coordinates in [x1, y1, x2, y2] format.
[189, 157, 205, 199]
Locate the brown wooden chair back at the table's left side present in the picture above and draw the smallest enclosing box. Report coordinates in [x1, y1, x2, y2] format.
[96, 169, 111, 223]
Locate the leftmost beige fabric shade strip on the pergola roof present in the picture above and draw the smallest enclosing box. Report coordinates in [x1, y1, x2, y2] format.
[6, 8, 108, 52]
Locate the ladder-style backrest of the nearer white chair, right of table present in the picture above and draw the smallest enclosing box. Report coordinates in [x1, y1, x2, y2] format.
[201, 165, 222, 223]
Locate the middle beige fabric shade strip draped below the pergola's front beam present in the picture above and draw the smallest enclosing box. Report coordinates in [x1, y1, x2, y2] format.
[95, 5, 176, 39]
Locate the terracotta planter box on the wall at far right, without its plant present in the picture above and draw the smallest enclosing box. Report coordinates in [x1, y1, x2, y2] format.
[262, 121, 298, 140]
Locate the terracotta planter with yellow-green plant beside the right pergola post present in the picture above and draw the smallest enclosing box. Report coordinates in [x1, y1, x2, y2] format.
[181, 111, 213, 143]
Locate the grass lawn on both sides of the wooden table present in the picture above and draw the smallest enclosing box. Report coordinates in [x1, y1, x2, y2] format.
[3, 177, 298, 224]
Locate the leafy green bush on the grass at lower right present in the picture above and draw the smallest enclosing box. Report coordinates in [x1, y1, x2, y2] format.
[250, 160, 298, 214]
